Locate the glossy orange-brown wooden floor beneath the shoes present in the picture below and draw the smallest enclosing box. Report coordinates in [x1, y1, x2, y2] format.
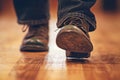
[0, 10, 120, 80]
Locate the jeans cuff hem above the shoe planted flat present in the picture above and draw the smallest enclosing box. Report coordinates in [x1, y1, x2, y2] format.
[18, 19, 49, 25]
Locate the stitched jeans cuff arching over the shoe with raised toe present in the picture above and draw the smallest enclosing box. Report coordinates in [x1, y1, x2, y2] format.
[57, 13, 96, 31]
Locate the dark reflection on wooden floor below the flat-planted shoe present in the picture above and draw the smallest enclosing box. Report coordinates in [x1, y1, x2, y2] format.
[10, 52, 47, 80]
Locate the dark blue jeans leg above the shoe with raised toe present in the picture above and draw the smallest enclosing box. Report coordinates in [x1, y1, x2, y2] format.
[57, 0, 96, 31]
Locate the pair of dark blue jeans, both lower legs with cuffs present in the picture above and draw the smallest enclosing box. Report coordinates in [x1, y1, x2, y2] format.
[14, 0, 96, 31]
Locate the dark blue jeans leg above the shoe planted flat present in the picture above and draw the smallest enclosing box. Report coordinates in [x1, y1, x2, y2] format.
[14, 0, 49, 25]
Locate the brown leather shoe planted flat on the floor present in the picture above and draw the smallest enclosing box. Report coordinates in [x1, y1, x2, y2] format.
[20, 25, 49, 51]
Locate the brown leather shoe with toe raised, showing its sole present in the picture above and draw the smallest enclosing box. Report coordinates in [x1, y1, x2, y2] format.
[56, 19, 93, 58]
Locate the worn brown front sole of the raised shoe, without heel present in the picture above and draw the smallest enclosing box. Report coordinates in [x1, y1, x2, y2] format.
[56, 26, 93, 53]
